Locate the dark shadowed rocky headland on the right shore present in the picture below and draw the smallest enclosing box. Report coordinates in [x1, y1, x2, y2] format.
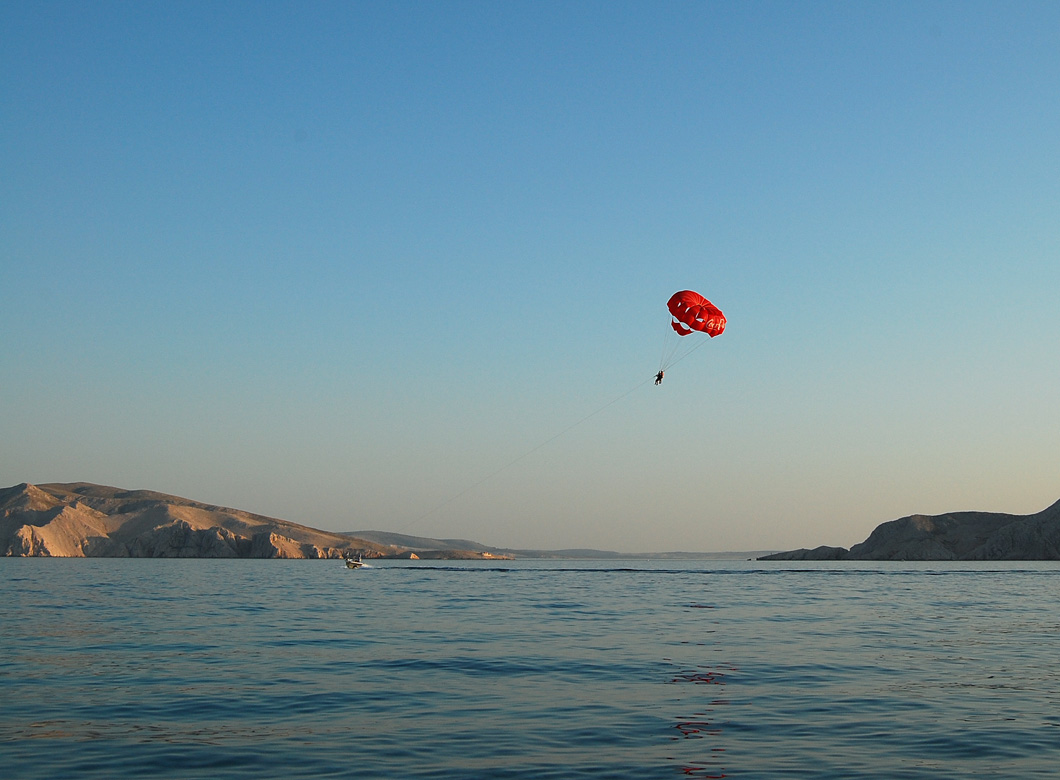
[759, 501, 1060, 561]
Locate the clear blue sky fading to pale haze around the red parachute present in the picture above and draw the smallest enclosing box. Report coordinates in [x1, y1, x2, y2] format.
[0, 0, 1060, 551]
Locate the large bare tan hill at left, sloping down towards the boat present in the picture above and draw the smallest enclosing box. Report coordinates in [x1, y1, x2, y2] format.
[0, 482, 384, 559]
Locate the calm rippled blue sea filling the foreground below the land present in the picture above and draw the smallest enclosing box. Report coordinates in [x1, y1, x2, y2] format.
[0, 559, 1060, 780]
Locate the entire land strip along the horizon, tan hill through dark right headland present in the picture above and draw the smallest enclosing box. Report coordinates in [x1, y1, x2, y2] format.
[0, 482, 1060, 561]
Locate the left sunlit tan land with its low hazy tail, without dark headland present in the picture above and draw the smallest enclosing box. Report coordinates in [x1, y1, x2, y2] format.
[0, 482, 762, 561]
